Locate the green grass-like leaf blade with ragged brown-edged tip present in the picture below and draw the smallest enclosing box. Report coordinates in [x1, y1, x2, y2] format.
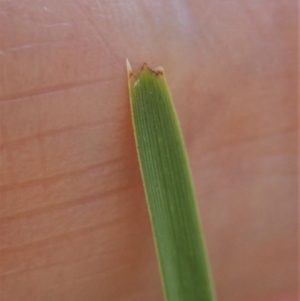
[127, 61, 214, 301]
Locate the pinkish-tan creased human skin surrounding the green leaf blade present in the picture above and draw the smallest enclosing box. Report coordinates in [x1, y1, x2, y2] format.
[0, 0, 297, 301]
